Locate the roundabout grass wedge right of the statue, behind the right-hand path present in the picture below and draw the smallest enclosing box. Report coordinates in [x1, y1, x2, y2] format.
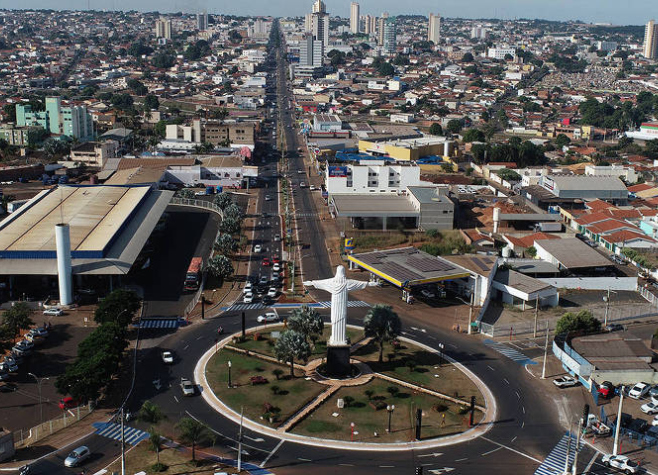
[352, 342, 484, 405]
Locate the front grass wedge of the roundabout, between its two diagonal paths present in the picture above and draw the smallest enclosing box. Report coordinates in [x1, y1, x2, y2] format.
[293, 378, 482, 443]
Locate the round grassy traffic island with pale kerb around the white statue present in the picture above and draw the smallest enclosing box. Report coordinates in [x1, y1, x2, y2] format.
[195, 325, 495, 450]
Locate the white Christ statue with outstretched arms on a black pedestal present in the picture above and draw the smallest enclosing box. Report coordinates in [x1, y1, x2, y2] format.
[304, 266, 376, 377]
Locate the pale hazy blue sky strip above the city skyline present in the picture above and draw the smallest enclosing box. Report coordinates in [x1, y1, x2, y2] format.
[12, 0, 658, 24]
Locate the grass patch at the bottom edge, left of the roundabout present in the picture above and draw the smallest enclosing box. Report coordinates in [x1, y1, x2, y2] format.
[108, 441, 237, 475]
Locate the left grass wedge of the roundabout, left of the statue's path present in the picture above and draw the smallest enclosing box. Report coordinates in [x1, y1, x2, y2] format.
[206, 349, 325, 427]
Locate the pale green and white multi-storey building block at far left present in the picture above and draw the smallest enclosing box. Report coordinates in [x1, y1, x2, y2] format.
[16, 97, 94, 141]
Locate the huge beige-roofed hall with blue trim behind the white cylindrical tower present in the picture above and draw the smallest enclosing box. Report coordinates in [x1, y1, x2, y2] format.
[0, 185, 173, 280]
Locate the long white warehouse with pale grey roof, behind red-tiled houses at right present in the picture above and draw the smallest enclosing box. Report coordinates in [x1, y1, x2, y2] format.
[539, 175, 628, 204]
